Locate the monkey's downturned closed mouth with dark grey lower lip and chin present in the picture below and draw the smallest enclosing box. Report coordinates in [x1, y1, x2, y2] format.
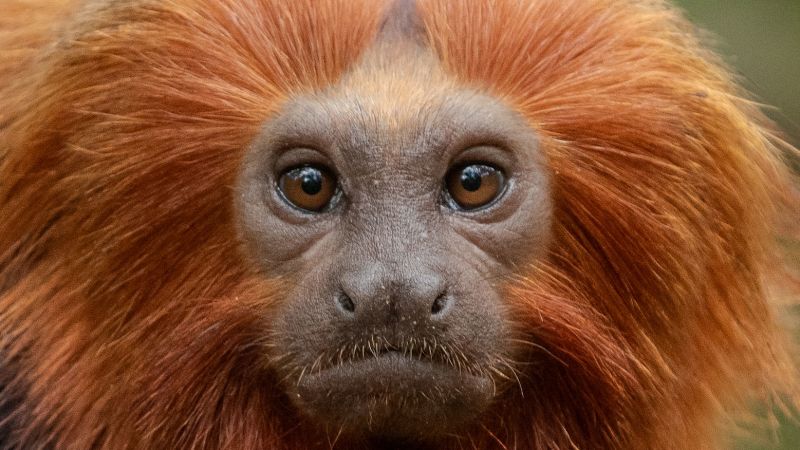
[290, 346, 494, 437]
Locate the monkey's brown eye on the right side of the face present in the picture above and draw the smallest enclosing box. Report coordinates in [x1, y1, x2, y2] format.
[445, 164, 506, 211]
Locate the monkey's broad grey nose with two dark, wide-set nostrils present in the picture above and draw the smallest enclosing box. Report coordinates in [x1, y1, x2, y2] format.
[334, 264, 451, 326]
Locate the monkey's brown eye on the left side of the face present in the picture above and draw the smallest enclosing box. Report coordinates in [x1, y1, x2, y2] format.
[278, 166, 336, 212]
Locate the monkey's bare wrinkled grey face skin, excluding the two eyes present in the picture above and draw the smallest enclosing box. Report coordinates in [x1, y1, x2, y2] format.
[237, 22, 552, 440]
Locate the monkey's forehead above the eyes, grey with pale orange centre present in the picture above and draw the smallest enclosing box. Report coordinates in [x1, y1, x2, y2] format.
[268, 44, 529, 169]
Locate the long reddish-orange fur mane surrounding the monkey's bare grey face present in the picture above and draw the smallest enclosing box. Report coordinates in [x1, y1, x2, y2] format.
[0, 0, 794, 450]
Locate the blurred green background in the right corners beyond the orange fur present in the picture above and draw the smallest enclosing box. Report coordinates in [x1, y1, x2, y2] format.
[674, 0, 800, 450]
